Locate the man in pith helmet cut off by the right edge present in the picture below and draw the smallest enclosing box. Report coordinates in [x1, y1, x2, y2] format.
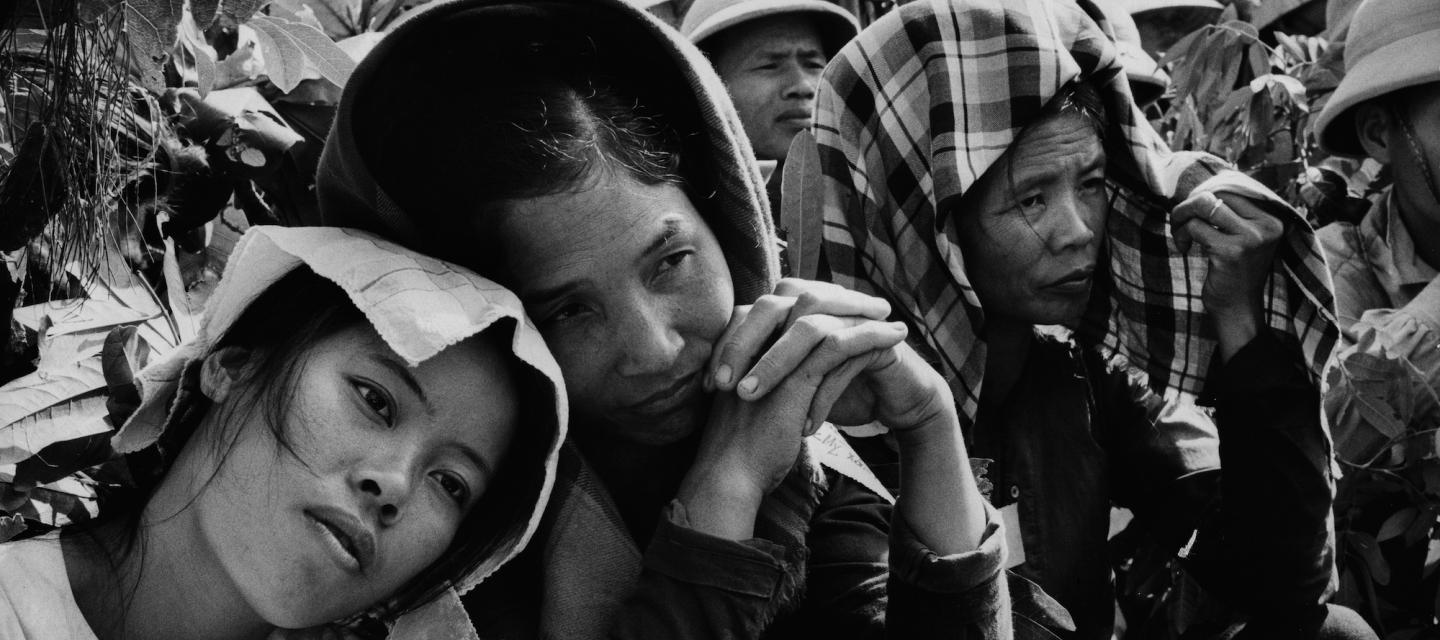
[1316, 0, 1440, 464]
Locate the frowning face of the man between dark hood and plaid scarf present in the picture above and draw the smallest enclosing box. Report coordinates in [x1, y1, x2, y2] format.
[711, 16, 825, 160]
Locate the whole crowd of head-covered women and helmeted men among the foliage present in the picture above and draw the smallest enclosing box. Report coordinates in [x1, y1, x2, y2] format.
[0, 0, 1440, 640]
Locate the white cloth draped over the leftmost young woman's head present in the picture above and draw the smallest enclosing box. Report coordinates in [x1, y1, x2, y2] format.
[112, 226, 569, 639]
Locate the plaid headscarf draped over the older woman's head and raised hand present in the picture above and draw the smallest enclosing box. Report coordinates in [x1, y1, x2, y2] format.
[815, 0, 1336, 424]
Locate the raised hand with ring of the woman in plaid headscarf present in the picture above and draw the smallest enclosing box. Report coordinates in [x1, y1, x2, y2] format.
[1171, 192, 1284, 360]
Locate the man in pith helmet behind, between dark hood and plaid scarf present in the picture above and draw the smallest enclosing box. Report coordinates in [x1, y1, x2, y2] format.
[680, 0, 860, 161]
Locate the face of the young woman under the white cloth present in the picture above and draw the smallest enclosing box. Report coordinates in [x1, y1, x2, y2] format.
[177, 326, 518, 627]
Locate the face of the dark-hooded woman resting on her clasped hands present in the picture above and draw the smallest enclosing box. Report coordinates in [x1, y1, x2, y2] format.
[500, 170, 734, 445]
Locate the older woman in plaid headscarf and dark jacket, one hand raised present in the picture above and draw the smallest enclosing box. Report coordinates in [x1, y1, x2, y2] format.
[816, 0, 1367, 639]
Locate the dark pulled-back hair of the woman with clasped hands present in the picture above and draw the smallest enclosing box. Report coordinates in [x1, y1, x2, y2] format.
[372, 40, 687, 280]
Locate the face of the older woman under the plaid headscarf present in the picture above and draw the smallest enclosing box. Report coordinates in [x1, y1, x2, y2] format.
[956, 114, 1109, 324]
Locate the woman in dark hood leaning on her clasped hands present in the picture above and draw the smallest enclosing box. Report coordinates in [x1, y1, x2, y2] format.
[318, 0, 1009, 639]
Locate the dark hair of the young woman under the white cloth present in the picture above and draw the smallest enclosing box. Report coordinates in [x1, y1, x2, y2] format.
[68, 267, 557, 633]
